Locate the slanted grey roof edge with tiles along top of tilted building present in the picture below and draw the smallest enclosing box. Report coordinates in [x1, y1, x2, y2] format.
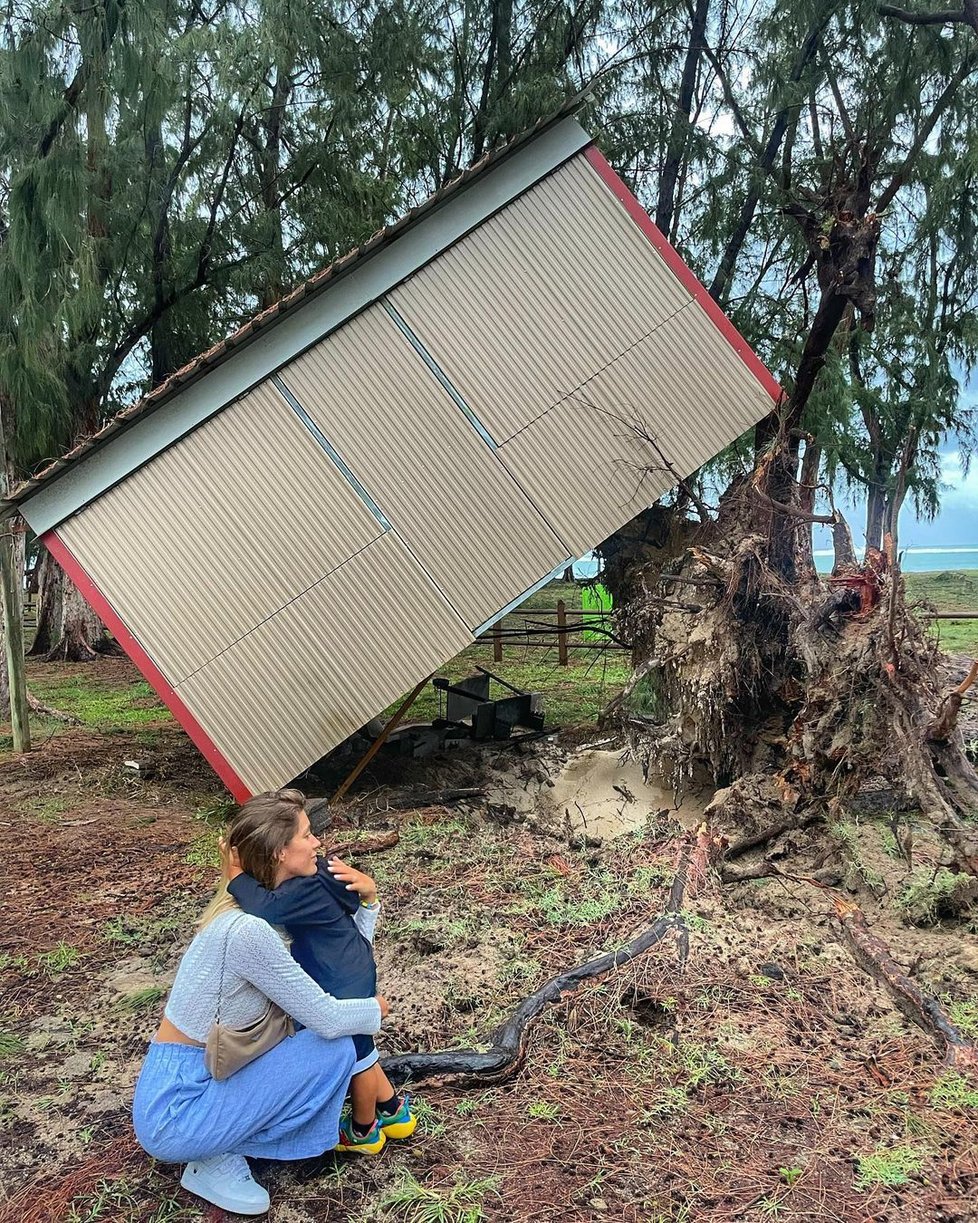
[11, 112, 592, 534]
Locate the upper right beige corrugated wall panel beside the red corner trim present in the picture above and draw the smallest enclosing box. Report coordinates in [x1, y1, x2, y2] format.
[390, 154, 692, 443]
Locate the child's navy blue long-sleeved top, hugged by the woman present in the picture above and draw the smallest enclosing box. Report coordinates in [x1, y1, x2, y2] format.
[227, 857, 377, 998]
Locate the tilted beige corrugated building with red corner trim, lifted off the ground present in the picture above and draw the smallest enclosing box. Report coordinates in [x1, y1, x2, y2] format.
[0, 107, 779, 800]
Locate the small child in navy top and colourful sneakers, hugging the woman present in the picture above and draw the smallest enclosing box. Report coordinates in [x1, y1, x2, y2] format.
[227, 816, 417, 1155]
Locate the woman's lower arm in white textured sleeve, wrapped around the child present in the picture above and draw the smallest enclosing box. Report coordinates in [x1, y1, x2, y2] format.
[227, 918, 383, 1040]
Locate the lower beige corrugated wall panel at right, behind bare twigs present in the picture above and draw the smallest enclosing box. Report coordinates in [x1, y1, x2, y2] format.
[498, 302, 770, 554]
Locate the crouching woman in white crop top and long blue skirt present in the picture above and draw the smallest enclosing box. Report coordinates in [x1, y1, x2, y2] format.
[132, 794, 386, 1214]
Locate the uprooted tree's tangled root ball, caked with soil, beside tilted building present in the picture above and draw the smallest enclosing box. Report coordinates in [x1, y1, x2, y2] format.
[608, 484, 978, 873]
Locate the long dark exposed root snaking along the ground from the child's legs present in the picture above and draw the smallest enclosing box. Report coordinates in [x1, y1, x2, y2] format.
[383, 828, 694, 1084]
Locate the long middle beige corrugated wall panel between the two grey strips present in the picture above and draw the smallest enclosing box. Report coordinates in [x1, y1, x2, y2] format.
[281, 306, 567, 629]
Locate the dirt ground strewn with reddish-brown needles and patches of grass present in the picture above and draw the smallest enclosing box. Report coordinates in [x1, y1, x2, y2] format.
[0, 662, 978, 1223]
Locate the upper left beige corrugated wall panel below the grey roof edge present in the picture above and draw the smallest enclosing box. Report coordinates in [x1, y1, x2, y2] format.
[59, 384, 381, 684]
